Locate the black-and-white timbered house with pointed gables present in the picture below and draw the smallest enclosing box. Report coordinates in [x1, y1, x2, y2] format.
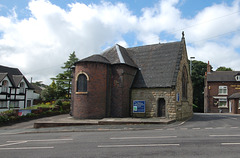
[0, 65, 39, 112]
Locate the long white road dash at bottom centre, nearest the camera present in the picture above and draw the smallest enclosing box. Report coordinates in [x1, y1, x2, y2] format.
[98, 144, 180, 148]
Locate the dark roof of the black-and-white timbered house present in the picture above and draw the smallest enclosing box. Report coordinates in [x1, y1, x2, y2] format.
[0, 65, 33, 89]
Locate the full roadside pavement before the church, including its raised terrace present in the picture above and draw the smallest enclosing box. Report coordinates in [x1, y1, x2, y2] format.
[0, 114, 176, 136]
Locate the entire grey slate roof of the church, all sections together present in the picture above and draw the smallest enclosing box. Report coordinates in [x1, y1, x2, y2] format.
[77, 37, 185, 88]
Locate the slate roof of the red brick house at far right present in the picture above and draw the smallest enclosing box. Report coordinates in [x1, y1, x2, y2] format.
[207, 71, 240, 82]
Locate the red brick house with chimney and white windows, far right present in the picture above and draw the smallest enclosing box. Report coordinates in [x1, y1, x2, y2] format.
[204, 62, 240, 114]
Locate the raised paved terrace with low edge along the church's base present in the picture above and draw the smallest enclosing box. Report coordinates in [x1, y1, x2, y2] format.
[33, 114, 175, 128]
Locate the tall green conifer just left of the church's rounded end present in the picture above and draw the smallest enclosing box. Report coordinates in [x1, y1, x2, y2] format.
[52, 51, 79, 98]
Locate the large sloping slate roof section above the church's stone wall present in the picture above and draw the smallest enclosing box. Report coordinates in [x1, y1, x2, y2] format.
[127, 42, 182, 88]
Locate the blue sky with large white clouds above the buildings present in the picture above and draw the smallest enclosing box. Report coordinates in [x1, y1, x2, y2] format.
[0, 0, 240, 84]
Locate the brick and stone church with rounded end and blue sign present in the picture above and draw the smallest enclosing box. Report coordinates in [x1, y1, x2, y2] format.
[71, 34, 193, 120]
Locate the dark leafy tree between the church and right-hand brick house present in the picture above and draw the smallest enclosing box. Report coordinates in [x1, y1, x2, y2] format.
[191, 60, 212, 112]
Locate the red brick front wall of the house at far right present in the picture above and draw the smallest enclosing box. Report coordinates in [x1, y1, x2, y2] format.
[206, 82, 240, 113]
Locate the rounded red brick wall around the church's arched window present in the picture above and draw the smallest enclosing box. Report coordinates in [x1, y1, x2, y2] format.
[72, 62, 109, 119]
